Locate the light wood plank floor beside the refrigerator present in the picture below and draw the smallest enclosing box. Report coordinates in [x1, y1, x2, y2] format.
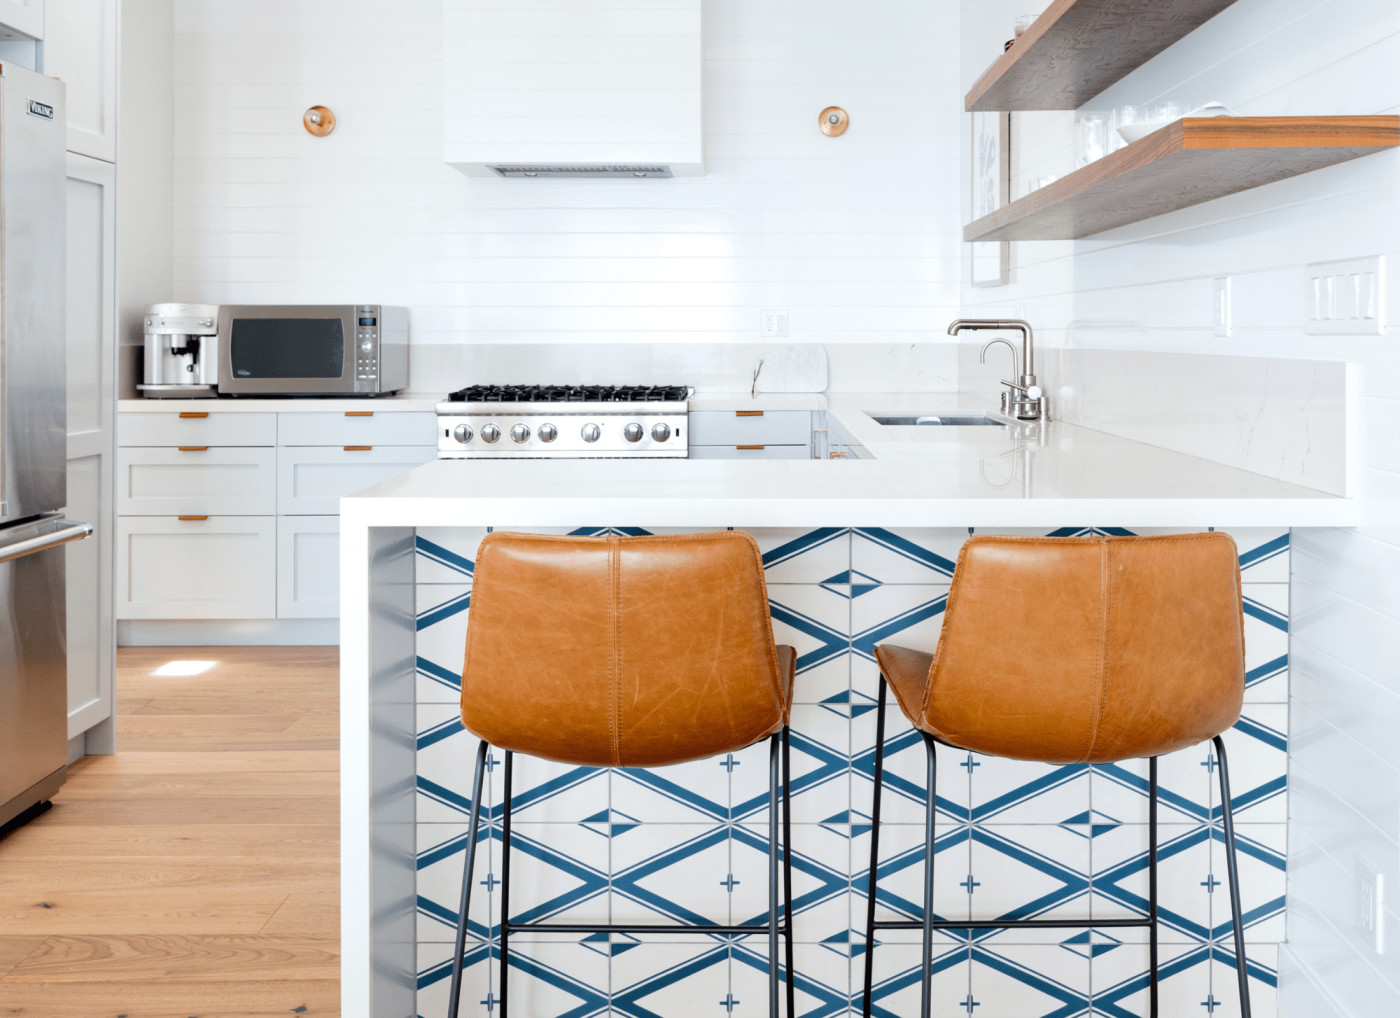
[0, 647, 340, 1018]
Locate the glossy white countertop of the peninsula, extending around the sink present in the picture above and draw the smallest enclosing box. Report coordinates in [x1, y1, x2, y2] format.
[340, 392, 1357, 529]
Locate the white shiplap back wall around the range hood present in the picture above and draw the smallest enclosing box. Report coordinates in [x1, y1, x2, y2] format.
[175, 0, 962, 391]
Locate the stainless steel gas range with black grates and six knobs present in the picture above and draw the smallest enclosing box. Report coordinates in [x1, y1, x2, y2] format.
[437, 385, 690, 459]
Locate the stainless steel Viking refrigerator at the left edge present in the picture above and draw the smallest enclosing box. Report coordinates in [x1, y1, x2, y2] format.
[0, 63, 92, 823]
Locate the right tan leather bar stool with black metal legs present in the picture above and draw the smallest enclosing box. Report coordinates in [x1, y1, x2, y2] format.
[864, 534, 1250, 1018]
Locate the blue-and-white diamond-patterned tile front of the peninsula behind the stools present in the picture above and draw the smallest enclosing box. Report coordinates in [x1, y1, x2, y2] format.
[417, 527, 1289, 1018]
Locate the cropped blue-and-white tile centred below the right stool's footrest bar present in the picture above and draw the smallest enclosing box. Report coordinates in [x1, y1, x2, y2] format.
[963, 931, 1089, 1018]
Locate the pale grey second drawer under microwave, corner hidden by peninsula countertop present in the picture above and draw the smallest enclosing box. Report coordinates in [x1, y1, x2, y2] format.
[277, 445, 437, 517]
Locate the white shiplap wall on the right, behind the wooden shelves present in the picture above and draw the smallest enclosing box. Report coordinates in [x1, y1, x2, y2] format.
[962, 0, 1400, 1018]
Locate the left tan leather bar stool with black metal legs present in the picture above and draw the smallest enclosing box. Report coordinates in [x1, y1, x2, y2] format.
[448, 531, 797, 1018]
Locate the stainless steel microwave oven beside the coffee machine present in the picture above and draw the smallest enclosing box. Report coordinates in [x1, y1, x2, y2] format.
[218, 304, 409, 396]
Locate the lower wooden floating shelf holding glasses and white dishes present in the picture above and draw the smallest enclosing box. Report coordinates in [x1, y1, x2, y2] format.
[963, 116, 1400, 241]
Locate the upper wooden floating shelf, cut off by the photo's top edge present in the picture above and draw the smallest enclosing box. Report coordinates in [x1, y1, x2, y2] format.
[965, 0, 1235, 112]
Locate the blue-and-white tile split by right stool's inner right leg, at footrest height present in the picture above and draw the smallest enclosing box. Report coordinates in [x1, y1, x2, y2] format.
[1089, 823, 1218, 944]
